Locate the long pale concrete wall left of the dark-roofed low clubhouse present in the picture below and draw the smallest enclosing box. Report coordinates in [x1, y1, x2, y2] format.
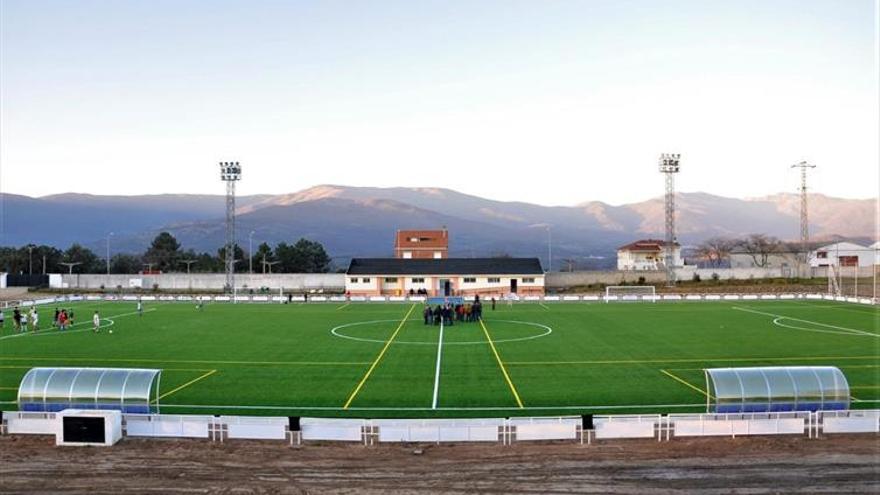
[62, 273, 345, 292]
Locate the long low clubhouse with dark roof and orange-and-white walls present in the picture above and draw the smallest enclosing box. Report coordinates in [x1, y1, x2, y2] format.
[345, 258, 544, 297]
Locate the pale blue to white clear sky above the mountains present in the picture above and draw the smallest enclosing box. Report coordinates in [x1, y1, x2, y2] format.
[0, 0, 880, 205]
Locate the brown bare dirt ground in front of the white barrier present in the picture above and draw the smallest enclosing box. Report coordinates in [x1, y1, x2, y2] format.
[0, 435, 880, 495]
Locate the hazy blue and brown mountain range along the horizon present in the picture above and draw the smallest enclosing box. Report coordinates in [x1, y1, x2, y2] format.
[0, 185, 877, 268]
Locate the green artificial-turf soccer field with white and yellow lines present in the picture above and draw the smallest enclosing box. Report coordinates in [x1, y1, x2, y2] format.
[0, 301, 880, 418]
